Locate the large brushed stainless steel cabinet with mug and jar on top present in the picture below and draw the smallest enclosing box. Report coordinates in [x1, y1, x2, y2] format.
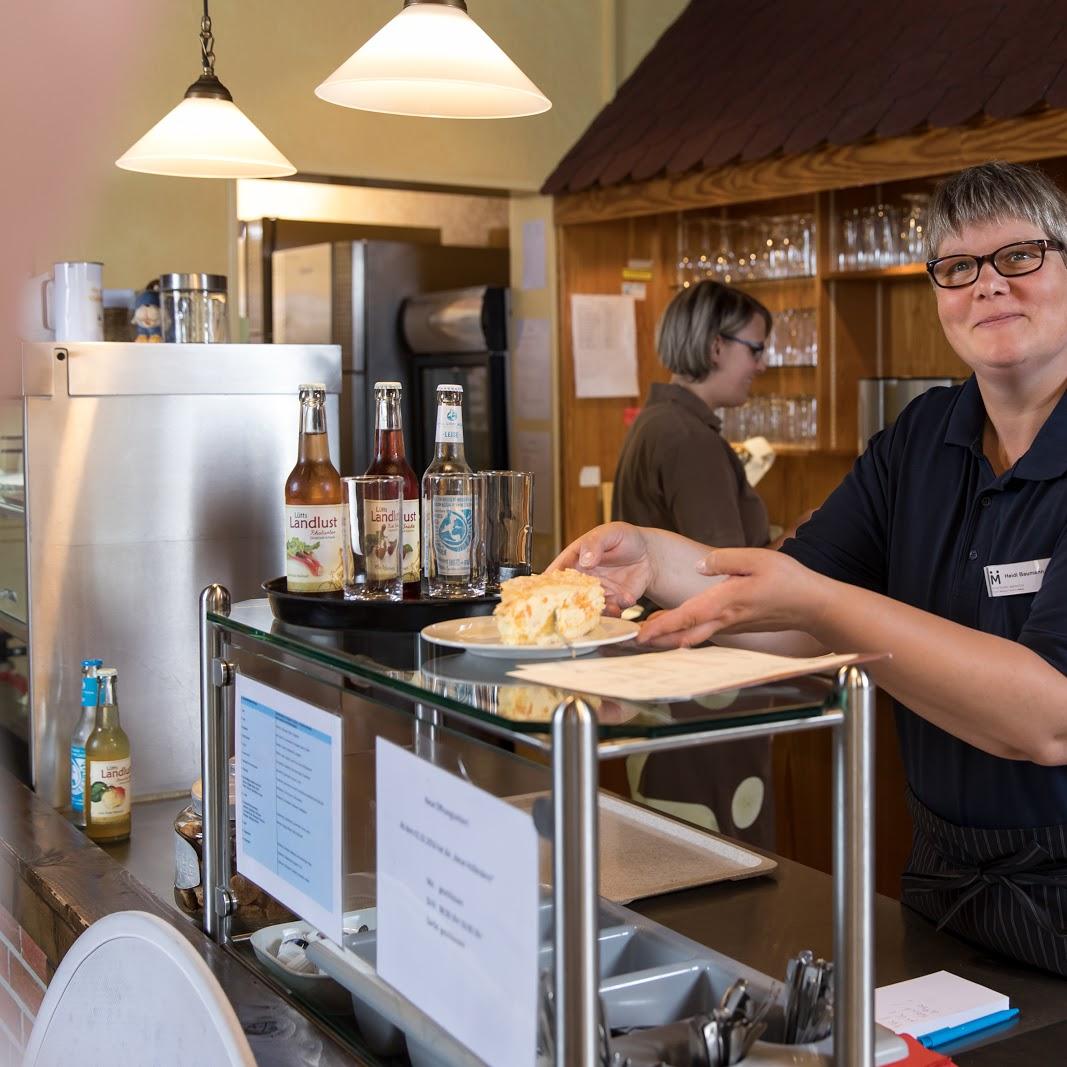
[8, 343, 340, 807]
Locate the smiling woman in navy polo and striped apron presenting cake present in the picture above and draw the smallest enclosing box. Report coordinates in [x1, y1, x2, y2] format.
[556, 163, 1067, 975]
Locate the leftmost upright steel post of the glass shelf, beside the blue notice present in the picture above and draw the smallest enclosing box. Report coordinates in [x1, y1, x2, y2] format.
[200, 585, 233, 944]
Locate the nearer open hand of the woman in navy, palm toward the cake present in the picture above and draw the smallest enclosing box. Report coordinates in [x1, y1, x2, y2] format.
[637, 548, 831, 649]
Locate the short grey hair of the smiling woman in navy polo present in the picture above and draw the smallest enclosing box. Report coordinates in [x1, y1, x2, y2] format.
[925, 161, 1067, 259]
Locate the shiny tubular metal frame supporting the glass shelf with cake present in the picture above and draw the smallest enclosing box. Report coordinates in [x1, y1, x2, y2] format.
[200, 585, 875, 1067]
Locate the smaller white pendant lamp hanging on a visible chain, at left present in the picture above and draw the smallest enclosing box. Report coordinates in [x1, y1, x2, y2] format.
[115, 0, 297, 178]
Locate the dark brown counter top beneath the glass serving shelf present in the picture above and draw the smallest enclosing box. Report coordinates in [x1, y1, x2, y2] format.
[0, 770, 1067, 1067]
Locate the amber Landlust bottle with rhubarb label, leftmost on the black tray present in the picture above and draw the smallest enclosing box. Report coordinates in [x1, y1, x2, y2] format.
[285, 384, 343, 593]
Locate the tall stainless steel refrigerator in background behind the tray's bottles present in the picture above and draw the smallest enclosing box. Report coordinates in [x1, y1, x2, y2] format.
[270, 240, 509, 475]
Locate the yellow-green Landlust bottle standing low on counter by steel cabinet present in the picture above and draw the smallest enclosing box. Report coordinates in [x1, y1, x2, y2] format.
[85, 667, 131, 844]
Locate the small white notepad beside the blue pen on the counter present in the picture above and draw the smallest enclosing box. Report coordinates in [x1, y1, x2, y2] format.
[874, 971, 1009, 1038]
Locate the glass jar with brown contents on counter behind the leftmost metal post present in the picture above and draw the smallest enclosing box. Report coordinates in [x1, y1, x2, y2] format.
[174, 760, 296, 934]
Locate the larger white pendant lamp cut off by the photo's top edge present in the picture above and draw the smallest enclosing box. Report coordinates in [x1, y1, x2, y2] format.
[315, 0, 552, 118]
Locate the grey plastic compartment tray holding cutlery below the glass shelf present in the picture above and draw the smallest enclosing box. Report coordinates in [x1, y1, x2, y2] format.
[307, 901, 907, 1067]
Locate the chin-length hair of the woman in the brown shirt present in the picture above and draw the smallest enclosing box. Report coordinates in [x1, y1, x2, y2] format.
[656, 281, 770, 382]
